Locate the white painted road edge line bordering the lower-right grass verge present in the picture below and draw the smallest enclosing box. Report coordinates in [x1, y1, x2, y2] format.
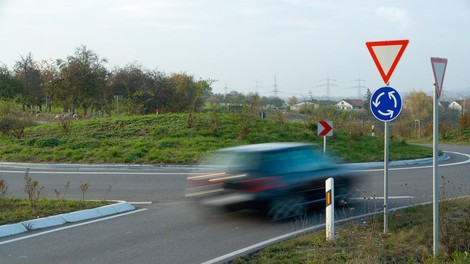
[202, 195, 470, 264]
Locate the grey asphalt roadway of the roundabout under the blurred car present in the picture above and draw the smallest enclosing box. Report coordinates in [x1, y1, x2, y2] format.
[0, 145, 470, 264]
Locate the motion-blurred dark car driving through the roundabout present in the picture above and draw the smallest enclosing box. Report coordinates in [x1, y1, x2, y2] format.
[185, 143, 353, 221]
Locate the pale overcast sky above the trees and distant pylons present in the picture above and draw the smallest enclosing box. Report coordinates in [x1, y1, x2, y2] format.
[0, 0, 470, 98]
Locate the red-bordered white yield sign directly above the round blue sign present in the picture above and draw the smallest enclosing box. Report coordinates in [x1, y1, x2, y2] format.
[366, 39, 410, 84]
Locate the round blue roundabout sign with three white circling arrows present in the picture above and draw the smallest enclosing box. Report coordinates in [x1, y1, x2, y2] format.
[370, 86, 402, 122]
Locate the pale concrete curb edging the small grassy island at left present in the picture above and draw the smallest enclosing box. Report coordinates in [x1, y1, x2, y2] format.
[0, 201, 135, 238]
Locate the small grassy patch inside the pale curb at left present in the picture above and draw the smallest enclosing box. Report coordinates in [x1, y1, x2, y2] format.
[0, 198, 110, 225]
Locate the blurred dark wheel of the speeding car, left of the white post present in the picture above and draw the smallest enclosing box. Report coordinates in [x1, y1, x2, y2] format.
[267, 195, 307, 221]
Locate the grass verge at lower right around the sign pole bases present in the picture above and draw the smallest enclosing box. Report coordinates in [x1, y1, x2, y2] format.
[233, 199, 470, 264]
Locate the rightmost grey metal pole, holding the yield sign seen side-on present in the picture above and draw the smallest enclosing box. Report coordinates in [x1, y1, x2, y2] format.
[432, 84, 439, 256]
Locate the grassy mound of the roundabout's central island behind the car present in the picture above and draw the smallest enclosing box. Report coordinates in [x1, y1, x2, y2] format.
[0, 113, 432, 165]
